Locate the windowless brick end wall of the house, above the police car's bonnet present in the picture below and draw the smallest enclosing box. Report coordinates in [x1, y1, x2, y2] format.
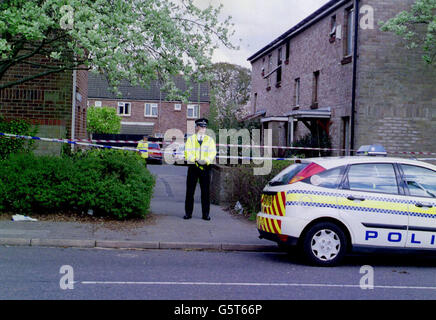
[356, 0, 436, 152]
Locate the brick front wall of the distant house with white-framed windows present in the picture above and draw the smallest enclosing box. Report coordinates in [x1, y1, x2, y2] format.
[89, 98, 209, 134]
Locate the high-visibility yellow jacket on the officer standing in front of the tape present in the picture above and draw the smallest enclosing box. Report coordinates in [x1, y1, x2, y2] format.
[185, 134, 216, 169]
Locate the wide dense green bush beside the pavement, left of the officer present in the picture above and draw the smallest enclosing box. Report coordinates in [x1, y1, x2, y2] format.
[0, 150, 155, 219]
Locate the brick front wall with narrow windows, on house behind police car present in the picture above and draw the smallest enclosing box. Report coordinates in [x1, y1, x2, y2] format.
[251, 2, 352, 151]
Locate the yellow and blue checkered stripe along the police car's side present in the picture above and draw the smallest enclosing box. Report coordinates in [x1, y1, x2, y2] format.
[286, 190, 436, 219]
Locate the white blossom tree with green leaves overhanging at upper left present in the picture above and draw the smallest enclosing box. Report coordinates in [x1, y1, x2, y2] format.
[0, 0, 234, 94]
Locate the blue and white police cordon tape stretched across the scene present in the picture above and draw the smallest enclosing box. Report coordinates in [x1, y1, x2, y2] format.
[0, 132, 436, 161]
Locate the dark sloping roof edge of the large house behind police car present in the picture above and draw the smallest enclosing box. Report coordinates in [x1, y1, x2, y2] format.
[247, 0, 351, 62]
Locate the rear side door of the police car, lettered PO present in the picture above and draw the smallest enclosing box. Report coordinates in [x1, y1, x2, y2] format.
[337, 163, 408, 247]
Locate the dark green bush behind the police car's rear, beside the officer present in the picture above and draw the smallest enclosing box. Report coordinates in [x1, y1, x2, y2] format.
[227, 161, 293, 220]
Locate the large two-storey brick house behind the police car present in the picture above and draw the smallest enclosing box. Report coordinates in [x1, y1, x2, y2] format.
[248, 0, 436, 154]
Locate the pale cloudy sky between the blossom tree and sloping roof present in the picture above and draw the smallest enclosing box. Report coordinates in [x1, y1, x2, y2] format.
[195, 0, 329, 69]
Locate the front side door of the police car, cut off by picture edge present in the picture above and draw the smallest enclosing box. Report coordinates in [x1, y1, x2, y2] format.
[400, 164, 436, 249]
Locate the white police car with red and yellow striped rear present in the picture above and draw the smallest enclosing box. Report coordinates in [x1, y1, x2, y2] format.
[257, 147, 436, 266]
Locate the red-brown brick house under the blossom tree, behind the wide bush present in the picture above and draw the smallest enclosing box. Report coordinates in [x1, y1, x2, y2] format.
[0, 55, 88, 154]
